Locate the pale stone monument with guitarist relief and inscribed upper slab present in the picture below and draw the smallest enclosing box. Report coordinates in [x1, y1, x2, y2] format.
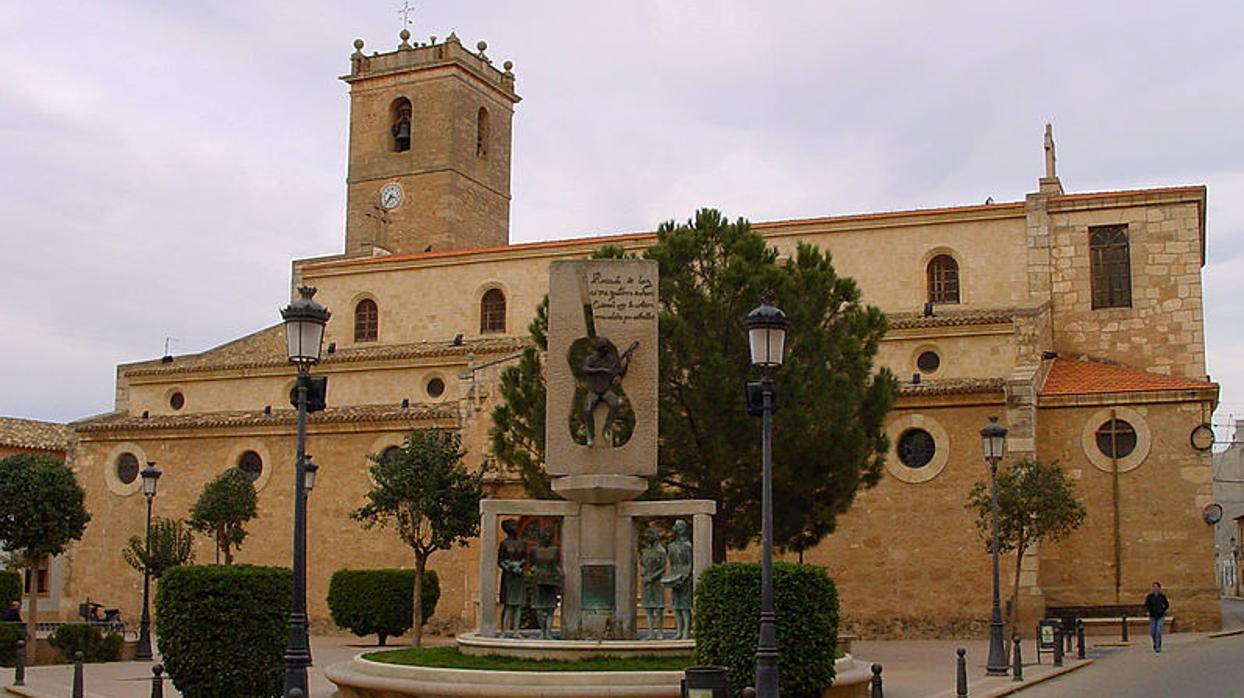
[479, 259, 717, 640]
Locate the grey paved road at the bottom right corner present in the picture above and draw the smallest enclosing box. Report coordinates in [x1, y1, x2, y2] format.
[1023, 633, 1244, 698]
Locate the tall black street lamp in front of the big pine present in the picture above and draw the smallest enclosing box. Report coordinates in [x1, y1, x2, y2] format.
[743, 297, 790, 698]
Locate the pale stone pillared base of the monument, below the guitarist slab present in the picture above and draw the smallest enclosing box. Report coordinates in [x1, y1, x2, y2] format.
[479, 495, 717, 640]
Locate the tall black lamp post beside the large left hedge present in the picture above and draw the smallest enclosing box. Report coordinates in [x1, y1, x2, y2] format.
[281, 286, 331, 697]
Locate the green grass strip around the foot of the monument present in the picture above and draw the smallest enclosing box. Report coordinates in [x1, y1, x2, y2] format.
[363, 647, 694, 672]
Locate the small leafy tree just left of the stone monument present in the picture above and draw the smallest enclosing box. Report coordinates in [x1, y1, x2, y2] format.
[351, 429, 484, 647]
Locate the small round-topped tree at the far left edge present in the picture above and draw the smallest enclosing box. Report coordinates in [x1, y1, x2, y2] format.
[0, 453, 91, 652]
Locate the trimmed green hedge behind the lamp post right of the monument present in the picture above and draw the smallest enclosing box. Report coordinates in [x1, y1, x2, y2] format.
[694, 562, 838, 698]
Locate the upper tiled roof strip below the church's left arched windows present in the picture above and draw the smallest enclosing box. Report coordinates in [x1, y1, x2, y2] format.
[122, 325, 530, 376]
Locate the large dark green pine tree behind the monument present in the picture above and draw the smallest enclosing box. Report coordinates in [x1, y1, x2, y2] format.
[493, 209, 898, 560]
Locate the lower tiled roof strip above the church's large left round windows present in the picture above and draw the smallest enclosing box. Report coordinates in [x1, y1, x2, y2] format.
[75, 403, 458, 432]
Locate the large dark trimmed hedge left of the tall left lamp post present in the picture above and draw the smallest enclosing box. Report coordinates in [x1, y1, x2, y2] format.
[156, 565, 294, 698]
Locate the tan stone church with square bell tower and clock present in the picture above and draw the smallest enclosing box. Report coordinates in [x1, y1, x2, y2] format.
[57, 31, 1219, 637]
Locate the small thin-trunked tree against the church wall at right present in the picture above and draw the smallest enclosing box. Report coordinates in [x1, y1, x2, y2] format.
[967, 459, 1087, 628]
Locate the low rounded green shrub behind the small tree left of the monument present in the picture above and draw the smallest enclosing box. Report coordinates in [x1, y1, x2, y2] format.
[328, 570, 440, 644]
